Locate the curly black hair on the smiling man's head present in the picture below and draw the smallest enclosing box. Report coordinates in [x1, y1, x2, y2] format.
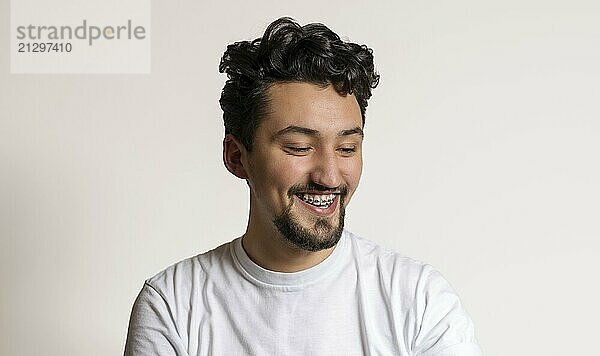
[219, 17, 379, 151]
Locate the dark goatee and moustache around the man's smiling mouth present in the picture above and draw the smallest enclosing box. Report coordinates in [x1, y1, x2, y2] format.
[273, 184, 348, 252]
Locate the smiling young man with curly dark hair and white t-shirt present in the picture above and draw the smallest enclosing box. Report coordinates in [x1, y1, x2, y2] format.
[125, 18, 481, 356]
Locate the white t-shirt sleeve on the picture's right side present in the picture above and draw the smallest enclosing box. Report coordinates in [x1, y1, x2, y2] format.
[413, 265, 482, 356]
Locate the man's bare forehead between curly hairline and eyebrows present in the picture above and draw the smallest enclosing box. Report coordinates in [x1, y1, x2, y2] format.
[261, 82, 362, 135]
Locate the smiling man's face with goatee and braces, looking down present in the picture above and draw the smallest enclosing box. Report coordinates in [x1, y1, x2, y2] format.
[245, 83, 363, 251]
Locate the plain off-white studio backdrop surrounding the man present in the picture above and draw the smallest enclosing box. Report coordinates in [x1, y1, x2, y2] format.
[0, 0, 600, 356]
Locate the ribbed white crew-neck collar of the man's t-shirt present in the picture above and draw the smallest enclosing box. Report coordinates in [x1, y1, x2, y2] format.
[232, 230, 347, 287]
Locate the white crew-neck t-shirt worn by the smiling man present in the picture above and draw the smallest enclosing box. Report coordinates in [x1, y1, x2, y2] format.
[125, 231, 481, 356]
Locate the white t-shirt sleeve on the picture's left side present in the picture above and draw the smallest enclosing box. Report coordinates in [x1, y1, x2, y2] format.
[125, 283, 188, 356]
